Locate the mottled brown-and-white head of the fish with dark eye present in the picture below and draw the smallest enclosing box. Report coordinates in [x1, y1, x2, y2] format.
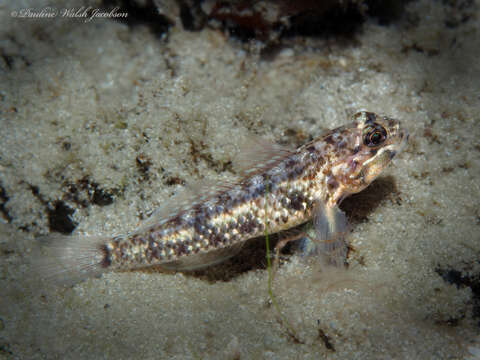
[325, 111, 408, 204]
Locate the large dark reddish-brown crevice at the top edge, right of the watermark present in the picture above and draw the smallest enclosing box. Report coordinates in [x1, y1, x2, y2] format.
[199, 0, 409, 46]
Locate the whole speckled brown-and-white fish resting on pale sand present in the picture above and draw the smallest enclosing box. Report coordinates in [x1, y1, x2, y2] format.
[38, 111, 409, 283]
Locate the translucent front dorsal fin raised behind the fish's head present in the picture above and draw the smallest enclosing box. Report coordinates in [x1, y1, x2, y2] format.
[233, 135, 295, 177]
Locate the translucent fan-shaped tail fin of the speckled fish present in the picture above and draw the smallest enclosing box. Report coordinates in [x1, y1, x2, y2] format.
[32, 235, 109, 285]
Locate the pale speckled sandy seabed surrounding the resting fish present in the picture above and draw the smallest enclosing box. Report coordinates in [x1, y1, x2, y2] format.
[0, 0, 480, 359]
